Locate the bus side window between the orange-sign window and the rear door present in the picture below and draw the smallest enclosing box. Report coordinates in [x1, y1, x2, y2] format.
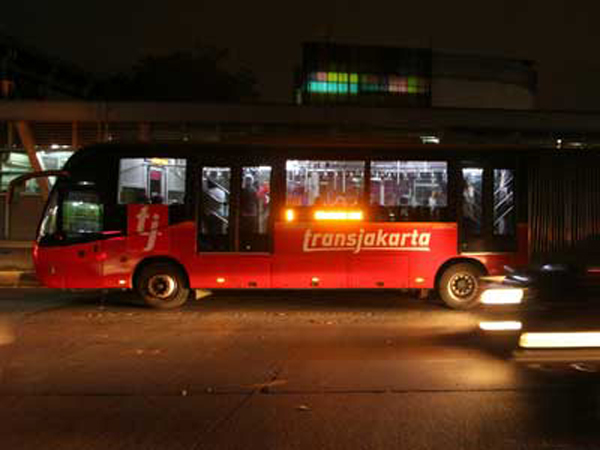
[370, 161, 448, 222]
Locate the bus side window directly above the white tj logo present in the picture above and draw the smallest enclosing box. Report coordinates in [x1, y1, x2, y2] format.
[118, 158, 186, 205]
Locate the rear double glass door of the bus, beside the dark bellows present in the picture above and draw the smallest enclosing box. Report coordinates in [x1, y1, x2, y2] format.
[458, 162, 517, 253]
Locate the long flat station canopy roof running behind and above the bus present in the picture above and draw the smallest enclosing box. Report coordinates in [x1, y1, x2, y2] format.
[0, 101, 600, 148]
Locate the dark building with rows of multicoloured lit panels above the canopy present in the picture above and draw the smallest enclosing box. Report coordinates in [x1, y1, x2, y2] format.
[295, 43, 537, 109]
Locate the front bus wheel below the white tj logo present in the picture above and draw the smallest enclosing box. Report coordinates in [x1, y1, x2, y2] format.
[134, 263, 190, 309]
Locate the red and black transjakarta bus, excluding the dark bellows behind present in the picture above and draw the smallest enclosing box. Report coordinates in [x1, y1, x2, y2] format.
[28, 144, 527, 309]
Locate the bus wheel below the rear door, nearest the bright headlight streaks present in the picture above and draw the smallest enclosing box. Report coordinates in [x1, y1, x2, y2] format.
[438, 263, 484, 310]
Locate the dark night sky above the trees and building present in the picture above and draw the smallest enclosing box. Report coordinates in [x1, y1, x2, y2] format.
[0, 0, 600, 111]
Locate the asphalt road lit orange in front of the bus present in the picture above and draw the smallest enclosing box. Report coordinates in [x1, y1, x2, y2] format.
[0, 289, 600, 450]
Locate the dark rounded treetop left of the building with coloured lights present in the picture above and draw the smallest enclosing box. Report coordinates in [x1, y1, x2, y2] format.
[96, 46, 257, 103]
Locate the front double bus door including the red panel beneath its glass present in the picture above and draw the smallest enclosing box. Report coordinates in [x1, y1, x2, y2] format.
[197, 165, 272, 288]
